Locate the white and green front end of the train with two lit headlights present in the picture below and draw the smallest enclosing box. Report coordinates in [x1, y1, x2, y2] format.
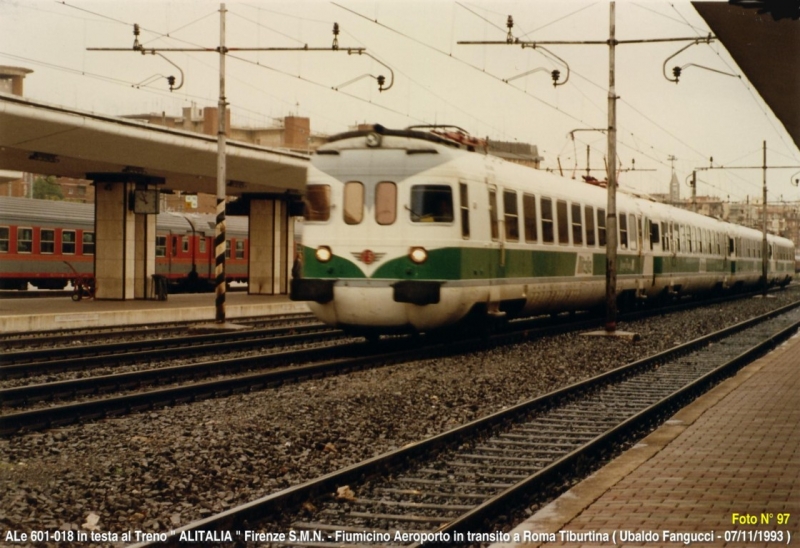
[290, 128, 478, 334]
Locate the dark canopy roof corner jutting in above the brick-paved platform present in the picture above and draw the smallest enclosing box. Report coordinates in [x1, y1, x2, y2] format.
[692, 0, 800, 152]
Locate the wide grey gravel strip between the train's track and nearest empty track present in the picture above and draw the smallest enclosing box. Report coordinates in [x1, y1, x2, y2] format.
[0, 290, 798, 532]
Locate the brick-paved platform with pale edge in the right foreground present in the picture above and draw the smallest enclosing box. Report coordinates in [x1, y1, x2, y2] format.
[492, 335, 800, 548]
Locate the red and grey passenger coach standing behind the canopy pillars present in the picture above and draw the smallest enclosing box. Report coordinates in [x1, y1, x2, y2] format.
[0, 197, 249, 291]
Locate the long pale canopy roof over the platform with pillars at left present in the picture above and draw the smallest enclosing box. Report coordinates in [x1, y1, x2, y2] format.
[0, 93, 309, 196]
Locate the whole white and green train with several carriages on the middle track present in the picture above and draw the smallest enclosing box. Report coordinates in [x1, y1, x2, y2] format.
[291, 126, 795, 334]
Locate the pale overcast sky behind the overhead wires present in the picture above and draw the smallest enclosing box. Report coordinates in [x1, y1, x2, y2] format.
[0, 0, 800, 201]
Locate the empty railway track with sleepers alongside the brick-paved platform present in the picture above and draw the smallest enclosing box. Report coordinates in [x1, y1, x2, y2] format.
[131, 303, 800, 548]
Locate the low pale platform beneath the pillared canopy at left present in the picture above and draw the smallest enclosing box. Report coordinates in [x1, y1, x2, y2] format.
[0, 291, 308, 333]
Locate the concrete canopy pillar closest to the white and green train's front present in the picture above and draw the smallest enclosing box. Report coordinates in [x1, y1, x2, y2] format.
[247, 198, 294, 295]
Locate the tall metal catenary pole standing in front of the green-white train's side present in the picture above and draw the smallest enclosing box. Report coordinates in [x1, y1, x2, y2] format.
[605, 2, 617, 333]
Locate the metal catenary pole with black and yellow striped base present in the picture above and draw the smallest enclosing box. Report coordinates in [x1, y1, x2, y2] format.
[214, 3, 227, 323]
